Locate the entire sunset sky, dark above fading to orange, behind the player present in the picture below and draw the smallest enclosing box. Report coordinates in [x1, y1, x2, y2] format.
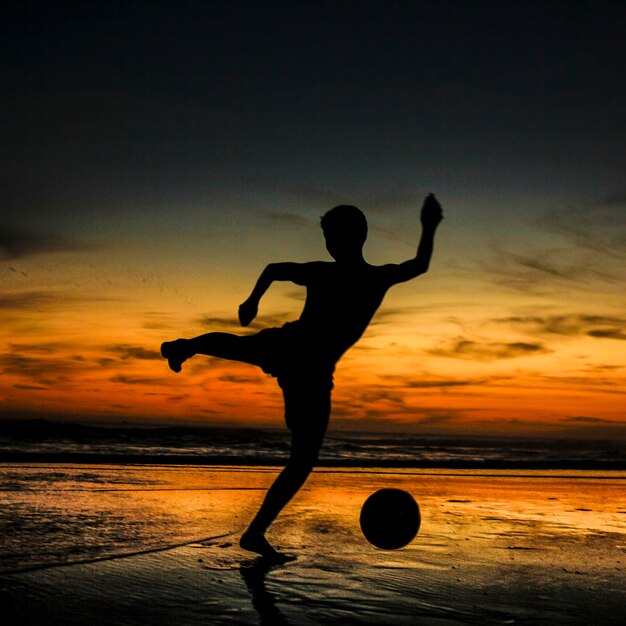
[0, 0, 626, 438]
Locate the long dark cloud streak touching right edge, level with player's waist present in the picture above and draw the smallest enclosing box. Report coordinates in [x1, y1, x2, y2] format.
[494, 314, 626, 340]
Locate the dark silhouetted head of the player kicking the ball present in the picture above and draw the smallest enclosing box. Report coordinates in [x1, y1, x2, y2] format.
[321, 204, 367, 261]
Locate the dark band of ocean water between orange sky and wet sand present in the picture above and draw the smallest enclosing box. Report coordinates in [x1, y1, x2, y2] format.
[0, 420, 626, 469]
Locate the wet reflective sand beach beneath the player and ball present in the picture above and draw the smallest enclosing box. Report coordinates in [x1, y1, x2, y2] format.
[0, 464, 626, 625]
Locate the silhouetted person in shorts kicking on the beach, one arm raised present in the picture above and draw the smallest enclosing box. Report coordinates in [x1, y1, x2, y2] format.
[161, 194, 442, 560]
